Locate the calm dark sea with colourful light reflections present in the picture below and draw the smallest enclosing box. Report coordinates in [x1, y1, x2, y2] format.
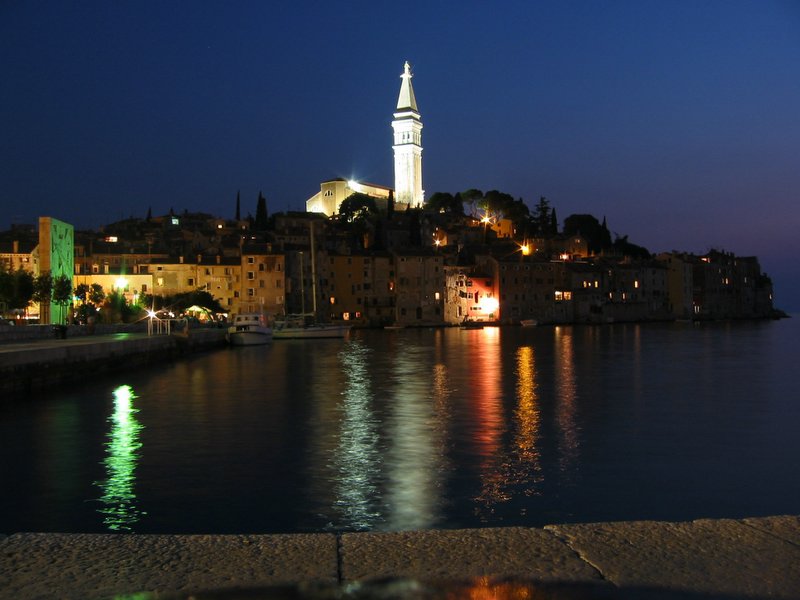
[0, 318, 800, 533]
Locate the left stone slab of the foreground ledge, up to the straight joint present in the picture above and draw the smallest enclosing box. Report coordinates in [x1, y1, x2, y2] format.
[0, 533, 338, 599]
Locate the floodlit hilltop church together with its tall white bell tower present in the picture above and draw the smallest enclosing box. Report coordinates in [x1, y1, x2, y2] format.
[306, 61, 425, 216]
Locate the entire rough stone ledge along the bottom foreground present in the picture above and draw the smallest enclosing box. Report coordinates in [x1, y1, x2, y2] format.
[0, 516, 800, 600]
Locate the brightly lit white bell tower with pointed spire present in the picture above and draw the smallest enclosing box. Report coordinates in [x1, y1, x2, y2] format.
[392, 61, 425, 208]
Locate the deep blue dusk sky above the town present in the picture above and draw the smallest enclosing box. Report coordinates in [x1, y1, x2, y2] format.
[0, 0, 800, 310]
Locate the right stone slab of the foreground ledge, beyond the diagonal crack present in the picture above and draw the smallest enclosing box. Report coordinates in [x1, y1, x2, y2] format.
[546, 517, 800, 598]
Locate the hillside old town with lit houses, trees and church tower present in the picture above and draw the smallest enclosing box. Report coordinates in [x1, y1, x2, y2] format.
[0, 62, 775, 327]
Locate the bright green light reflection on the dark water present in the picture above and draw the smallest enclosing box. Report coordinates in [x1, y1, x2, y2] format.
[96, 385, 145, 531]
